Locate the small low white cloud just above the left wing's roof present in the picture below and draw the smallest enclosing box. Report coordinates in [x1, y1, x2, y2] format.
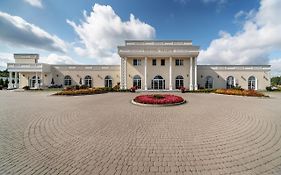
[40, 53, 78, 64]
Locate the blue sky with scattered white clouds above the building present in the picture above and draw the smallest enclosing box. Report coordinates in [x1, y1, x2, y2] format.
[0, 0, 281, 75]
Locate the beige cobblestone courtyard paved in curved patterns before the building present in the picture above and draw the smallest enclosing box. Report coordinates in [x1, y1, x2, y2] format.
[0, 91, 281, 175]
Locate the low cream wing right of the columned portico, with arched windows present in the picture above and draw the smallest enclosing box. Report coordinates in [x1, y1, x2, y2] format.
[197, 65, 271, 90]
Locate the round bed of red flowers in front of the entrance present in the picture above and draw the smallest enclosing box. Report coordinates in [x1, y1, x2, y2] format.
[133, 94, 185, 105]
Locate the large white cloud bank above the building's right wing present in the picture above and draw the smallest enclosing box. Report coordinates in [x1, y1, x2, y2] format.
[199, 0, 281, 70]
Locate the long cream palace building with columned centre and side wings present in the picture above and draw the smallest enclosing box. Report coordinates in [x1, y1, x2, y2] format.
[7, 40, 270, 90]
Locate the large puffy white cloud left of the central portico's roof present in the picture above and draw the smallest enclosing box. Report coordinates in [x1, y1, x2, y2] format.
[67, 4, 155, 64]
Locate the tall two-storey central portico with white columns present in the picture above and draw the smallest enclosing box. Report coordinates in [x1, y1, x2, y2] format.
[118, 40, 199, 90]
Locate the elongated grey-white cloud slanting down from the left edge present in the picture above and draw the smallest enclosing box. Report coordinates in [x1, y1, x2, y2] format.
[0, 11, 67, 53]
